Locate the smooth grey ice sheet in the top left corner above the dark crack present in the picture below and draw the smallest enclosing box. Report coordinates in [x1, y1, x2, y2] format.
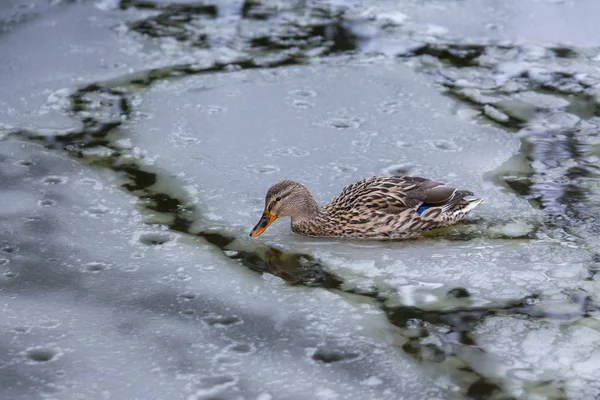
[0, 2, 149, 129]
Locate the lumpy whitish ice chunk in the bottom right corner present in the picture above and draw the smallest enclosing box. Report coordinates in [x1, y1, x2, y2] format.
[476, 317, 600, 399]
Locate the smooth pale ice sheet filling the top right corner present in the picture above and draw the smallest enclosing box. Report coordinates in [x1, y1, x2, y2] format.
[369, 0, 598, 47]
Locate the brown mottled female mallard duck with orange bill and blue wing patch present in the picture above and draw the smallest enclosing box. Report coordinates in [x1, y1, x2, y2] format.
[250, 176, 483, 239]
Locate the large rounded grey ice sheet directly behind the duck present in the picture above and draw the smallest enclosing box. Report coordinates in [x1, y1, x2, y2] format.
[131, 65, 533, 228]
